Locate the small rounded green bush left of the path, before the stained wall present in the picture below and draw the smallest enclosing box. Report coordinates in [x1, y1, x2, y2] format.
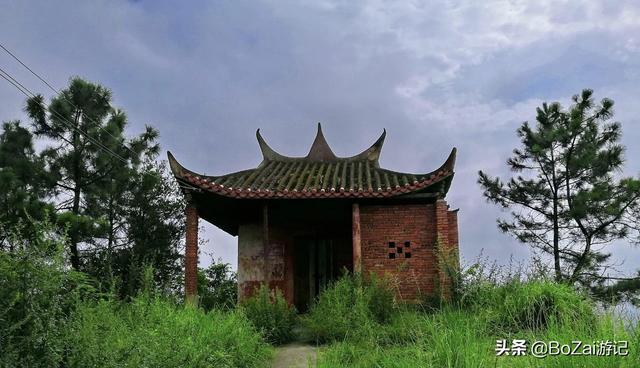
[241, 284, 296, 344]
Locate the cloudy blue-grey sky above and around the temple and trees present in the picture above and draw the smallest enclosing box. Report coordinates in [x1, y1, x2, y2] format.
[0, 0, 640, 274]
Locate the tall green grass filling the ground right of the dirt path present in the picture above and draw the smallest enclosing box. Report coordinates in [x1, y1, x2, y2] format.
[308, 281, 640, 368]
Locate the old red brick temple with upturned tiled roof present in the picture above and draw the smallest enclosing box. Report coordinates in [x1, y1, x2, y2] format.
[169, 125, 458, 309]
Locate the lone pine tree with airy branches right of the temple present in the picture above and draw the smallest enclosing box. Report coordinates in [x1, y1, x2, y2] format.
[478, 89, 640, 286]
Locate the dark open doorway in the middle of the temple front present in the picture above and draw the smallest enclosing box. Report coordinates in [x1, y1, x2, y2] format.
[293, 237, 352, 312]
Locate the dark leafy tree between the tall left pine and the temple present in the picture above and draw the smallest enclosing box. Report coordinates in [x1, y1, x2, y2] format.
[100, 160, 184, 297]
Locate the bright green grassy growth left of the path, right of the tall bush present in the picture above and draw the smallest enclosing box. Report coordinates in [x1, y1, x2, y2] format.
[67, 295, 271, 368]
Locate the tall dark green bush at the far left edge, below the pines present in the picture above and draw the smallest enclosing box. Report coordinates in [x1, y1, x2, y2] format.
[0, 223, 93, 367]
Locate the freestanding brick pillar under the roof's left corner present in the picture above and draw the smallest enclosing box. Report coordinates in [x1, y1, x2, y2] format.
[184, 203, 198, 301]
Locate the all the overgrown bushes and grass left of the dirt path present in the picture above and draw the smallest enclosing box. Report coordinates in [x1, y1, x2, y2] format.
[0, 220, 271, 368]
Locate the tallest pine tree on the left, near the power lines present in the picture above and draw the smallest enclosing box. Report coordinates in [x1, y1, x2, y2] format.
[26, 78, 124, 270]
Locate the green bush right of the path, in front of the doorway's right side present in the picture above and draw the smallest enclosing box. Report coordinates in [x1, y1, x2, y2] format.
[304, 274, 397, 342]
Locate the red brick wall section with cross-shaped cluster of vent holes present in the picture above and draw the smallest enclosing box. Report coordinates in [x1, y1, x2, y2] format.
[360, 200, 458, 301]
